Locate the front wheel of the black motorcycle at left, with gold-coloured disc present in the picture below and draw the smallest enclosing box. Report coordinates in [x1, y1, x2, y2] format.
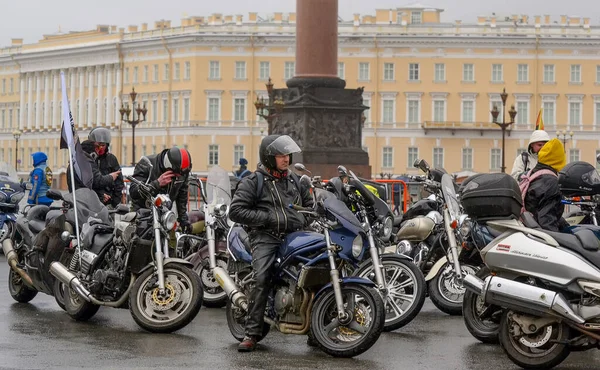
[129, 263, 203, 333]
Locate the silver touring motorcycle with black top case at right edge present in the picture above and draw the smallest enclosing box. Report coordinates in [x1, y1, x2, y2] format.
[464, 174, 600, 369]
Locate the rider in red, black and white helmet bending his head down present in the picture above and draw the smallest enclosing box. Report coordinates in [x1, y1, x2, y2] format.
[129, 146, 192, 233]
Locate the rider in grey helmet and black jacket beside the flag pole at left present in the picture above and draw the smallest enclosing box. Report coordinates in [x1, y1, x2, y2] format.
[88, 127, 124, 207]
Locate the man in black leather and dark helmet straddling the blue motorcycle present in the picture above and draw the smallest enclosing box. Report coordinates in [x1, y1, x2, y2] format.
[229, 135, 313, 352]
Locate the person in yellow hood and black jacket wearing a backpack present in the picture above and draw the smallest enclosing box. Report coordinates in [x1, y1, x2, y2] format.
[519, 139, 569, 231]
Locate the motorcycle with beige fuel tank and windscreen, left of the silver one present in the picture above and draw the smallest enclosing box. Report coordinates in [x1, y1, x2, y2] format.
[396, 159, 481, 315]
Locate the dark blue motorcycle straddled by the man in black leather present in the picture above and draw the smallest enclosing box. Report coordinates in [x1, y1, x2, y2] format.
[205, 166, 385, 357]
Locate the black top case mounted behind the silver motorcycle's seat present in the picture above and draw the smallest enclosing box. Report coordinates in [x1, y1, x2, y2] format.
[460, 173, 523, 221]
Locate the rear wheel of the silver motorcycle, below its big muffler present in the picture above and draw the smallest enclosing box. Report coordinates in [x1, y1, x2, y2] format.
[499, 310, 570, 369]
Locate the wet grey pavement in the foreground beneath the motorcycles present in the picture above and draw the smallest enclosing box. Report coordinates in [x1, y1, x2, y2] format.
[0, 256, 600, 370]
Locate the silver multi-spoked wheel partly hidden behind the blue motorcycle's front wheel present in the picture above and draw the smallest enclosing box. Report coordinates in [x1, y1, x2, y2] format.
[355, 254, 426, 331]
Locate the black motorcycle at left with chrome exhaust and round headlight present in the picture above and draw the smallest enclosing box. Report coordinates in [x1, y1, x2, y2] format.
[50, 157, 202, 333]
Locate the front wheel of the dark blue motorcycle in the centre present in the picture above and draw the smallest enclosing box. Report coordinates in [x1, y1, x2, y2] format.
[310, 284, 385, 357]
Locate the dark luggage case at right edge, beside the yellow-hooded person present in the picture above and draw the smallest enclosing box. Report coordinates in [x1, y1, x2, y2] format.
[558, 161, 600, 197]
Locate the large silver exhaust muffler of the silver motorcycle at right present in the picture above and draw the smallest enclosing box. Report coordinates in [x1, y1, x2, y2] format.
[463, 275, 585, 324]
